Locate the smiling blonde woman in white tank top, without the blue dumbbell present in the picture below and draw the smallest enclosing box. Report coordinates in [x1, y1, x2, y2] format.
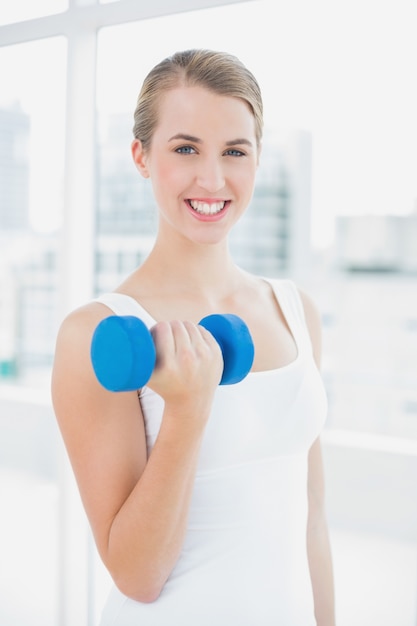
[52, 50, 334, 626]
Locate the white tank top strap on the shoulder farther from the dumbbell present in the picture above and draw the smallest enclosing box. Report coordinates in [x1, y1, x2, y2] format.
[266, 279, 312, 354]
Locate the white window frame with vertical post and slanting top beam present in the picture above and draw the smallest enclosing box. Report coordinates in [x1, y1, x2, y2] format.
[0, 0, 256, 626]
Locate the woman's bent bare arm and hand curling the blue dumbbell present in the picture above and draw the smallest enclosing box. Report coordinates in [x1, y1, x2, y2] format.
[52, 303, 222, 602]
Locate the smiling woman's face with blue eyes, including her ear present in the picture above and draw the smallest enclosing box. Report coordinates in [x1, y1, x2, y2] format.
[133, 87, 258, 243]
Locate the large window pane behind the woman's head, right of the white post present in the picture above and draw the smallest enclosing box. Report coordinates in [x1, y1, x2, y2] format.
[97, 0, 417, 448]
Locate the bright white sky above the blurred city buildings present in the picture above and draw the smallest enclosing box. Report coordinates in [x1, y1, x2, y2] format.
[0, 0, 417, 247]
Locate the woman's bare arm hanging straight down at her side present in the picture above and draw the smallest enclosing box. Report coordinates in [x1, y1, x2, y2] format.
[301, 293, 336, 626]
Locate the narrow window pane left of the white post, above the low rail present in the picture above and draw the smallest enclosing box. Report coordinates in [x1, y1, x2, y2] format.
[0, 38, 66, 382]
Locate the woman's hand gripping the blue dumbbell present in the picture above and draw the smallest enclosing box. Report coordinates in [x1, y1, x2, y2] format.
[148, 320, 223, 418]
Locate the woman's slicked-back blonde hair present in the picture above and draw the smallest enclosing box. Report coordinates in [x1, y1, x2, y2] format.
[133, 50, 263, 151]
